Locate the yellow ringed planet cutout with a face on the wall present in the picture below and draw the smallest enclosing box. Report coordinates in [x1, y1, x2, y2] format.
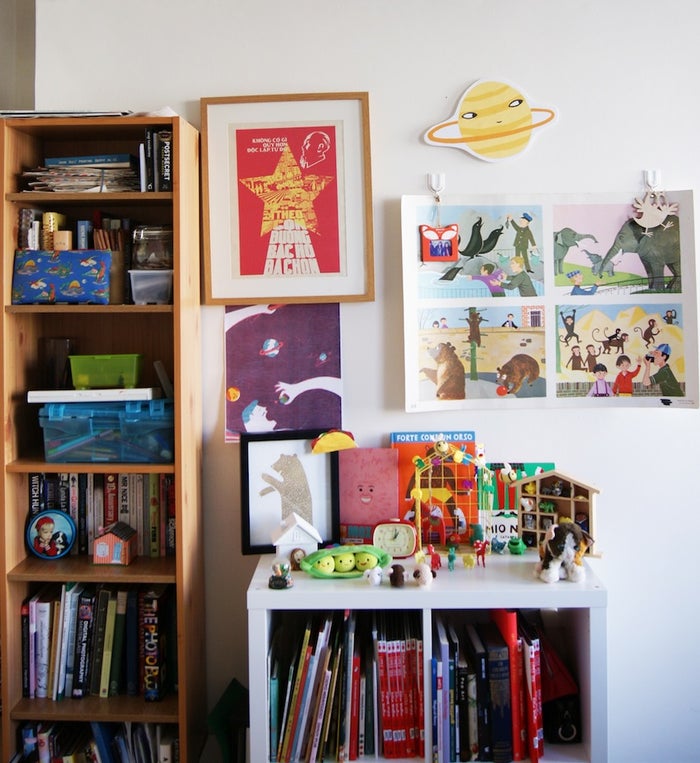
[425, 80, 556, 162]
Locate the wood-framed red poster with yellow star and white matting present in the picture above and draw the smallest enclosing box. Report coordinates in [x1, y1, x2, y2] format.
[200, 92, 374, 305]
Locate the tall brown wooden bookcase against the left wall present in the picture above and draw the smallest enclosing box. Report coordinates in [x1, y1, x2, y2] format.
[0, 117, 207, 763]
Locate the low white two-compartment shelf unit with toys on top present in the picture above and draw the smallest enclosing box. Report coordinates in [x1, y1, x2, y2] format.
[247, 554, 608, 763]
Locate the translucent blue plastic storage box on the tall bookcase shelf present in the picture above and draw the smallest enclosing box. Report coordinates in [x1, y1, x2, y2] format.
[39, 400, 174, 463]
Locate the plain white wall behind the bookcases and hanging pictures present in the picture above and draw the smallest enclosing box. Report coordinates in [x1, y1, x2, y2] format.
[36, 0, 700, 763]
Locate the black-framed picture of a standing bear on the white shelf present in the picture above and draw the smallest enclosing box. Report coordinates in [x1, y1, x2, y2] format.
[240, 429, 340, 555]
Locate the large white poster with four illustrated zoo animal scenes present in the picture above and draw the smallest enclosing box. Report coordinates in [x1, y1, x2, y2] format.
[402, 190, 698, 411]
